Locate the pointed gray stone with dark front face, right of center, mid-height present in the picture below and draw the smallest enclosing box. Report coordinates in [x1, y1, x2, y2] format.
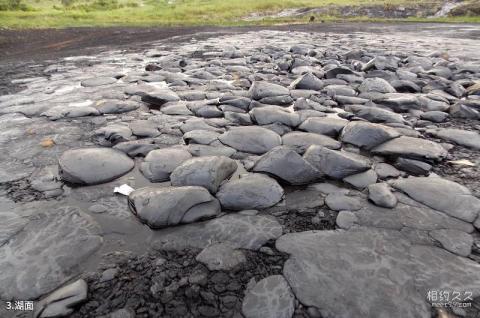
[340, 121, 400, 150]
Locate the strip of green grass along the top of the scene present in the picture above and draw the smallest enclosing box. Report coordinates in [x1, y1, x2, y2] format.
[0, 0, 480, 28]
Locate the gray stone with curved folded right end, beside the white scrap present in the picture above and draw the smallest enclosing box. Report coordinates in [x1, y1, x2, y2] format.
[128, 186, 220, 228]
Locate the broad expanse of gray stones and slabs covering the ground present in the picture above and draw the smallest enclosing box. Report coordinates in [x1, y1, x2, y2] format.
[0, 25, 480, 318]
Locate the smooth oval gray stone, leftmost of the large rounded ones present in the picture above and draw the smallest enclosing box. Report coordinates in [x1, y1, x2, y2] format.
[58, 148, 134, 185]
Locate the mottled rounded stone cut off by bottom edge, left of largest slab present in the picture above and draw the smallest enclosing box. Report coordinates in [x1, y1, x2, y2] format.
[242, 275, 295, 318]
